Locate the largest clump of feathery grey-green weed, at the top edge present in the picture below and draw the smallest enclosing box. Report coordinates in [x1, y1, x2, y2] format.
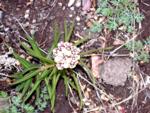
[91, 0, 144, 33]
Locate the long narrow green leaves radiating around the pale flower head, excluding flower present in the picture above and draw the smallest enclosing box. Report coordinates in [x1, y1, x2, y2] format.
[11, 23, 103, 112]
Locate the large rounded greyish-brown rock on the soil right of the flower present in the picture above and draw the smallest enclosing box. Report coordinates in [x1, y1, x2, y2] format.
[100, 58, 133, 86]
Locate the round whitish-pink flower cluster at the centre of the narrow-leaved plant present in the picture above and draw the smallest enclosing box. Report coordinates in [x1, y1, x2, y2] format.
[53, 42, 80, 70]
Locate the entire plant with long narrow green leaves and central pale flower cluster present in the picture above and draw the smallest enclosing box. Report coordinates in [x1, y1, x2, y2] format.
[11, 23, 111, 112]
